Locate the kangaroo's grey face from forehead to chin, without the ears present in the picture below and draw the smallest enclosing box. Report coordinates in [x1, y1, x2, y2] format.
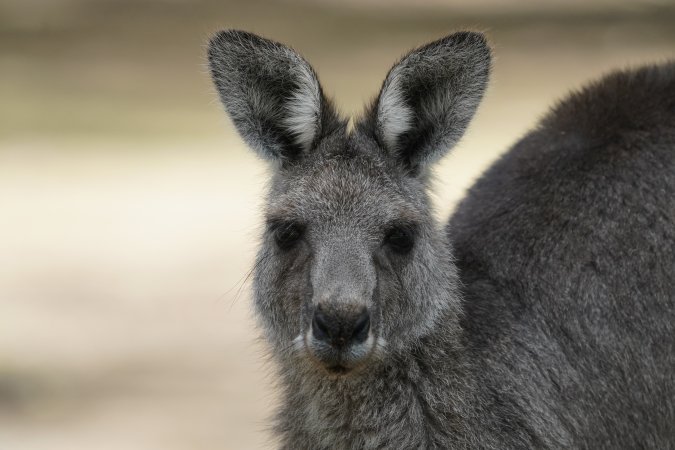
[256, 133, 449, 373]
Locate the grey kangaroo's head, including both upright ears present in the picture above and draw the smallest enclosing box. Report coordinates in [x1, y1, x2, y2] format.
[208, 31, 490, 374]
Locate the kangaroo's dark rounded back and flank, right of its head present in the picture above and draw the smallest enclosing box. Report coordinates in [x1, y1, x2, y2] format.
[448, 62, 675, 448]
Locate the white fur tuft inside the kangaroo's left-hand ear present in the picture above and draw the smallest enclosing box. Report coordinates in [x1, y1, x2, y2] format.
[284, 57, 321, 150]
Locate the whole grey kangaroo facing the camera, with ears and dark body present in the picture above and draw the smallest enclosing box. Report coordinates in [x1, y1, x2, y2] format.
[208, 30, 675, 450]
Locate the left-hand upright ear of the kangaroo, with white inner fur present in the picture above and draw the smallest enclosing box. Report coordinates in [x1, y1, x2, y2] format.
[208, 30, 340, 161]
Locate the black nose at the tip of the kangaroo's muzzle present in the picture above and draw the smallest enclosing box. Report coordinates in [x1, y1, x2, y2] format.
[312, 305, 370, 347]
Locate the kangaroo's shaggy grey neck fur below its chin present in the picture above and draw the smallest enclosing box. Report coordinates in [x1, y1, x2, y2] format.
[278, 328, 488, 449]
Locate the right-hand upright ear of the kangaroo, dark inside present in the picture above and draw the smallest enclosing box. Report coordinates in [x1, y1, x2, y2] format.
[359, 32, 491, 173]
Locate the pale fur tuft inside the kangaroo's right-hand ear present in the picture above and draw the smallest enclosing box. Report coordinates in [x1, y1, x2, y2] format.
[377, 67, 413, 149]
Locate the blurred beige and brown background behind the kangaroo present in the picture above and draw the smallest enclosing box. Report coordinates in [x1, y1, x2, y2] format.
[0, 0, 675, 450]
